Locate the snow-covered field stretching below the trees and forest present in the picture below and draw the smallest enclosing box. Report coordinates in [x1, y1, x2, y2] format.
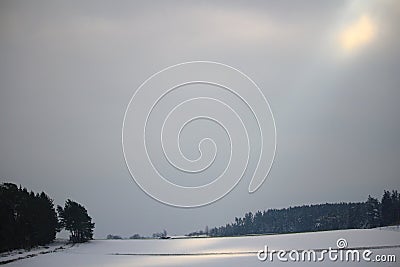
[0, 227, 400, 267]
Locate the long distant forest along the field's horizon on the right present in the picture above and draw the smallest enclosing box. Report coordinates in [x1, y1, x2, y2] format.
[188, 191, 400, 236]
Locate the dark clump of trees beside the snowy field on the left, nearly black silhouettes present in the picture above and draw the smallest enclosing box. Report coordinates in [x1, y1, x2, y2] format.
[0, 183, 94, 252]
